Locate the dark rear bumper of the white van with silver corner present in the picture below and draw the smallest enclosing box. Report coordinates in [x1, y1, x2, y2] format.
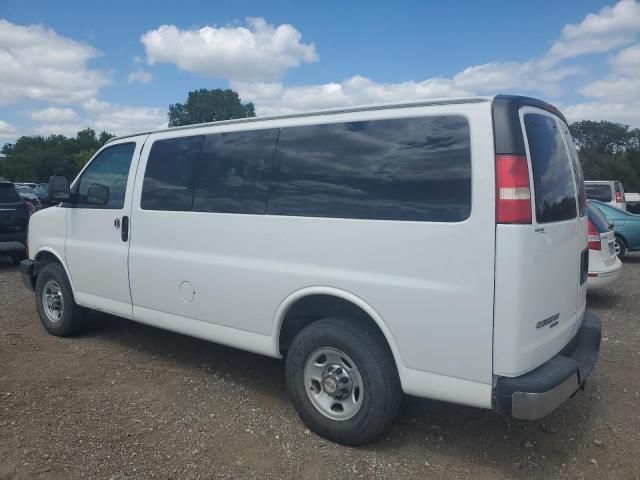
[495, 311, 602, 420]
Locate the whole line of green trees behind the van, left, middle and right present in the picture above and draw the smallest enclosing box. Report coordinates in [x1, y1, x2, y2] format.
[0, 89, 640, 192]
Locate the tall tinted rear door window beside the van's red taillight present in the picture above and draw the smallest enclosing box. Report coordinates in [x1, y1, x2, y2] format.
[524, 114, 577, 223]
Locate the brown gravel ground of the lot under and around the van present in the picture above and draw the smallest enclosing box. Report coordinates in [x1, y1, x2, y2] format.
[0, 255, 640, 480]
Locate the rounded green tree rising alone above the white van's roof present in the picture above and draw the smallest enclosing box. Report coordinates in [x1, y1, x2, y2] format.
[168, 88, 256, 127]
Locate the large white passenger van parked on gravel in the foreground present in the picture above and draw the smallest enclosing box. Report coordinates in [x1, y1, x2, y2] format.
[20, 96, 601, 445]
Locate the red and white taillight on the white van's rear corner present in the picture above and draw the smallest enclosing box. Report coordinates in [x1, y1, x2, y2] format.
[496, 155, 531, 224]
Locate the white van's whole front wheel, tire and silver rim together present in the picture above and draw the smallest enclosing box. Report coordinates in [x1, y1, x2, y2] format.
[36, 263, 84, 337]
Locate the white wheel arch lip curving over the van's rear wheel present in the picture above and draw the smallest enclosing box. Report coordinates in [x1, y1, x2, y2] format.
[272, 286, 404, 383]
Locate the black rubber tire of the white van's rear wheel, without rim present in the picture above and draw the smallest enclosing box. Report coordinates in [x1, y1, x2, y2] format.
[286, 318, 402, 446]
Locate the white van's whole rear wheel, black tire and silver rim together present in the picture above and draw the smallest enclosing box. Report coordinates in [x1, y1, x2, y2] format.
[286, 318, 402, 445]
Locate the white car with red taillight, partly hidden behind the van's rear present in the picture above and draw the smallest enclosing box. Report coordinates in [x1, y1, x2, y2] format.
[587, 202, 622, 290]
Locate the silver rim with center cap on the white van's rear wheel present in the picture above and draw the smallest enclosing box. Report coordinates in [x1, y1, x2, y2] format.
[304, 347, 364, 420]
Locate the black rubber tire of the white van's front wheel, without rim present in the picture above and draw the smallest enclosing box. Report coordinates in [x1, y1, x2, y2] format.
[36, 263, 86, 337]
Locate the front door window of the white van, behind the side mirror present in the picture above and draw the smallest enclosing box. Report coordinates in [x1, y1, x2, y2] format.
[73, 142, 136, 210]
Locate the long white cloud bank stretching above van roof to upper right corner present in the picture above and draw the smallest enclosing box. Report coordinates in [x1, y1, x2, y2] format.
[231, 0, 640, 126]
